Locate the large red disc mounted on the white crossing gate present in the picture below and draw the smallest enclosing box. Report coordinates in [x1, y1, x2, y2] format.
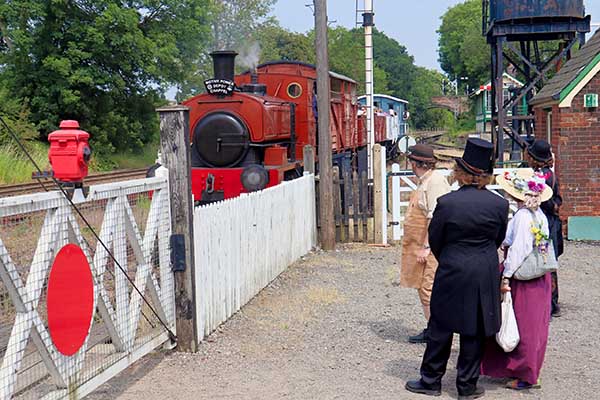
[47, 244, 94, 356]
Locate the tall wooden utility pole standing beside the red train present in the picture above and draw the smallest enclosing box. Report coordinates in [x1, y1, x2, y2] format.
[314, 0, 335, 250]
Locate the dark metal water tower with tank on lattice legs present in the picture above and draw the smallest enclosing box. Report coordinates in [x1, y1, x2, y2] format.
[482, 0, 590, 162]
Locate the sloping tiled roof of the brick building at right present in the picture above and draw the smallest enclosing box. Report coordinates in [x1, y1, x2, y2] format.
[530, 29, 600, 105]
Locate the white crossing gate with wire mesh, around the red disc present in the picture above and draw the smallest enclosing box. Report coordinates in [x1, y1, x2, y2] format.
[0, 178, 175, 400]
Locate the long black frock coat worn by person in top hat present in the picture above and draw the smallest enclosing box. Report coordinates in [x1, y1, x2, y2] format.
[429, 186, 508, 336]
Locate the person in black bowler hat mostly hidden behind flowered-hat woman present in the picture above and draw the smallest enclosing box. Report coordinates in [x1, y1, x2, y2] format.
[525, 139, 564, 317]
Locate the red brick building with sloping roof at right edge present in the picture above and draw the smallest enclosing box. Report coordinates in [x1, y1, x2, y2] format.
[530, 30, 600, 240]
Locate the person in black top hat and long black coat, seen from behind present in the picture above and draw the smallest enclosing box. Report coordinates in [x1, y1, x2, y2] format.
[406, 139, 508, 400]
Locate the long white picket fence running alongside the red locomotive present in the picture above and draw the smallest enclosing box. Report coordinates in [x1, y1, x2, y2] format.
[194, 175, 317, 339]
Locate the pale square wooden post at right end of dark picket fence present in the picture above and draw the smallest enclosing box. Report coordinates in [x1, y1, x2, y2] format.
[373, 144, 387, 244]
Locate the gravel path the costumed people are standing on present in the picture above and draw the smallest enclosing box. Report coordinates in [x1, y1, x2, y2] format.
[88, 244, 600, 400]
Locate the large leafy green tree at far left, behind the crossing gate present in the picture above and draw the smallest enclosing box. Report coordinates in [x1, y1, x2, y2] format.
[0, 0, 211, 153]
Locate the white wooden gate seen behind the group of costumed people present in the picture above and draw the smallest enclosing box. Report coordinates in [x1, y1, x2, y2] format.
[391, 164, 517, 241]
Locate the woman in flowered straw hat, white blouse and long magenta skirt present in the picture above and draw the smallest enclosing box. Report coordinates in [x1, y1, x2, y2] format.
[481, 169, 553, 390]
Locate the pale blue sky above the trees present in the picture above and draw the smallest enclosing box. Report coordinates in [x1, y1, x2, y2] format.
[273, 0, 600, 70]
